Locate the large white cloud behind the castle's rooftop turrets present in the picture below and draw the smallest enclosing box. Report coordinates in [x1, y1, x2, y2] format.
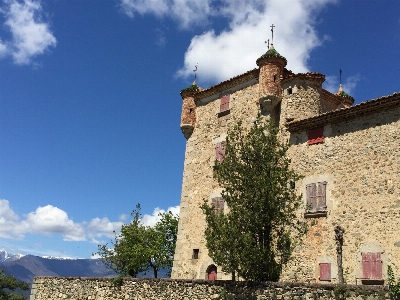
[120, 0, 336, 83]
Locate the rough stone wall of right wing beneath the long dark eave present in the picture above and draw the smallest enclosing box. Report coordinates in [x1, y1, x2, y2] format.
[282, 106, 400, 284]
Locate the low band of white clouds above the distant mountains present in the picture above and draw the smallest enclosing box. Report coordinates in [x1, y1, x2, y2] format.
[0, 199, 179, 244]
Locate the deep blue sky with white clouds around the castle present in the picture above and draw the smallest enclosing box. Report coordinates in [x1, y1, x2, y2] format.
[0, 0, 400, 258]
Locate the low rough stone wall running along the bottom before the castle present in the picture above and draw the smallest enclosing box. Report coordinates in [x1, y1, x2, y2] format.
[30, 277, 390, 300]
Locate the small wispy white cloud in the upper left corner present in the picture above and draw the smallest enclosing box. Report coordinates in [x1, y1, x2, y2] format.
[0, 0, 57, 65]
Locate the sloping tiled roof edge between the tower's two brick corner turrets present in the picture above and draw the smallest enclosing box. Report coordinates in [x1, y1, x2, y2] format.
[194, 68, 260, 101]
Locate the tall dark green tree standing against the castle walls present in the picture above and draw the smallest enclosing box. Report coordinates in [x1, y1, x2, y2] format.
[201, 116, 307, 281]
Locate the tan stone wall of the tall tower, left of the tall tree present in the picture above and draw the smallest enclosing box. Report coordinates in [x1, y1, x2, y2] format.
[172, 84, 259, 279]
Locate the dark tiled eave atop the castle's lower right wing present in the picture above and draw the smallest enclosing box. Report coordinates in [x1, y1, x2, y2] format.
[286, 92, 400, 132]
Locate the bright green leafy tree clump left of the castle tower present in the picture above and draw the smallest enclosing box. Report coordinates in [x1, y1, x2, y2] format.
[97, 204, 178, 278]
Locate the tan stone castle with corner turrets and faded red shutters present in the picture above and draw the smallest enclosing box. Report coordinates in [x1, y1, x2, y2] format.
[172, 42, 400, 284]
